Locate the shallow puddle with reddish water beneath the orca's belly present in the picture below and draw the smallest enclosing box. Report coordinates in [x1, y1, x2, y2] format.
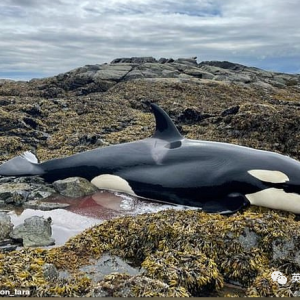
[9, 191, 184, 246]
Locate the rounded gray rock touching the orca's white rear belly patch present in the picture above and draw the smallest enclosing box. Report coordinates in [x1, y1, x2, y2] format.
[53, 177, 98, 198]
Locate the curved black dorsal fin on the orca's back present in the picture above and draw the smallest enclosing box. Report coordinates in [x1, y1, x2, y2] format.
[151, 103, 183, 141]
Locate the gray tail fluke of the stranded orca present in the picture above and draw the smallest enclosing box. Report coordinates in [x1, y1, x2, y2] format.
[0, 151, 44, 176]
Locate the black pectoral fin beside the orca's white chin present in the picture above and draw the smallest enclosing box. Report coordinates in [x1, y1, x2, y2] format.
[202, 194, 250, 214]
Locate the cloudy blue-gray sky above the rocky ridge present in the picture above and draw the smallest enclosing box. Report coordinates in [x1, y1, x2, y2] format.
[0, 0, 300, 80]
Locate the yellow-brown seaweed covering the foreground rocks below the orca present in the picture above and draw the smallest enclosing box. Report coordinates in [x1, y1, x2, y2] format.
[0, 207, 300, 296]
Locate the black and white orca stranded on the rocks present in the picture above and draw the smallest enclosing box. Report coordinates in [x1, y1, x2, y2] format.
[0, 104, 300, 213]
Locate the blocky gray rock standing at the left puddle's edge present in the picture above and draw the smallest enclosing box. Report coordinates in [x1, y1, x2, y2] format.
[10, 216, 55, 247]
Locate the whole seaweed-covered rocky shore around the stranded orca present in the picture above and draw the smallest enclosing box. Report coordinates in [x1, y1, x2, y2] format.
[0, 57, 300, 297]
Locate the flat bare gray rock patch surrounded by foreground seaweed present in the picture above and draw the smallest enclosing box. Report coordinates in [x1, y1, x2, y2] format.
[79, 254, 143, 282]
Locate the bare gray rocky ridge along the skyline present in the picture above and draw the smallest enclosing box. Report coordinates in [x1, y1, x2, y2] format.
[0, 57, 300, 98]
